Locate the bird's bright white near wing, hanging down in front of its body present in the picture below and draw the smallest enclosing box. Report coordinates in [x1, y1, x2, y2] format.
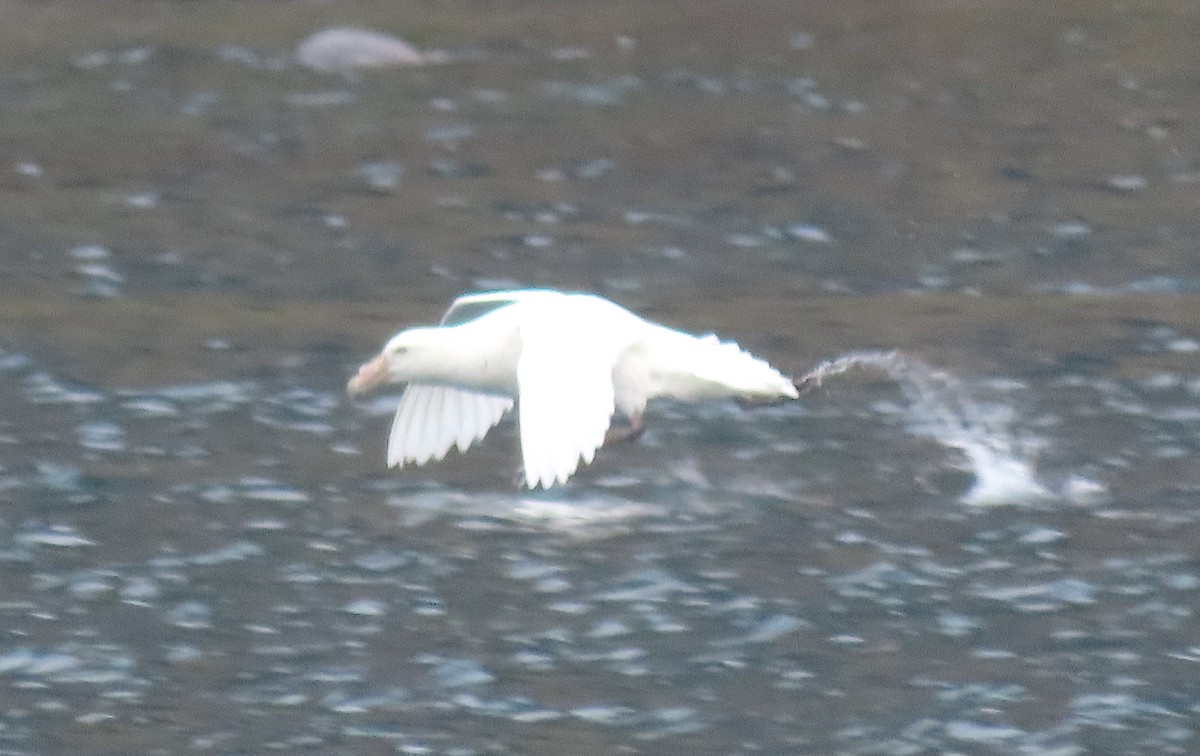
[517, 317, 624, 488]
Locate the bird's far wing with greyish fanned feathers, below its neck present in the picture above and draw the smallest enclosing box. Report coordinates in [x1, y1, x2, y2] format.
[388, 383, 512, 467]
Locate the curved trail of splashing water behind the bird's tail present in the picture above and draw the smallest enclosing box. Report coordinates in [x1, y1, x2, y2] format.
[796, 352, 1051, 506]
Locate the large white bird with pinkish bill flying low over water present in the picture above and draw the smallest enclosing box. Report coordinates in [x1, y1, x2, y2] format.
[346, 289, 799, 488]
